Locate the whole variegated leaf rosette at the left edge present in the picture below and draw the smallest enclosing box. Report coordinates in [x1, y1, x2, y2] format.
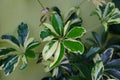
[0, 23, 40, 76]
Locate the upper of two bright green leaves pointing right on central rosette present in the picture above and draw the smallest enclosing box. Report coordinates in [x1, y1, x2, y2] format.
[66, 27, 86, 38]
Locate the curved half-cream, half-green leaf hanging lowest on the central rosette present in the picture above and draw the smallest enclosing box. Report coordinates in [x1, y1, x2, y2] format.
[50, 43, 65, 69]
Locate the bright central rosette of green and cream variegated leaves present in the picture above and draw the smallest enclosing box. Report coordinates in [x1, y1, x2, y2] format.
[40, 13, 86, 70]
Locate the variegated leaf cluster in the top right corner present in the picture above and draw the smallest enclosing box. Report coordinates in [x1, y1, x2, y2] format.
[95, 2, 120, 30]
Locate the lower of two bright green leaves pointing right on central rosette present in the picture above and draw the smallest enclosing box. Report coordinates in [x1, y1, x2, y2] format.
[64, 39, 84, 54]
